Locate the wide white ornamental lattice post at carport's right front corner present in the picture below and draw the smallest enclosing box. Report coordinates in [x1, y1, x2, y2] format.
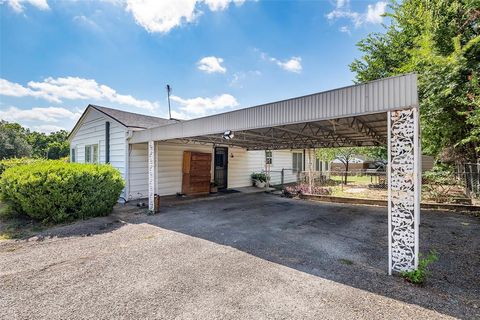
[387, 107, 422, 274]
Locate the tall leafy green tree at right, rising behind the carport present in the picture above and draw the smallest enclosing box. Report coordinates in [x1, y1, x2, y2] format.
[350, 0, 480, 161]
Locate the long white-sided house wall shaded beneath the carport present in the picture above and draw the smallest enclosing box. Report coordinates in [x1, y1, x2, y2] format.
[128, 142, 330, 199]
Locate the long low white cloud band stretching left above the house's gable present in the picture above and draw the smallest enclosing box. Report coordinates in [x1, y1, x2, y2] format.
[0, 77, 159, 111]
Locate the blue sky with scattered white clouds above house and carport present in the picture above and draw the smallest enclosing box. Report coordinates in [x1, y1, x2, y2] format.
[0, 0, 387, 132]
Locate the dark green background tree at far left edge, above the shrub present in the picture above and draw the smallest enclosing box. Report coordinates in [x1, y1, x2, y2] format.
[0, 120, 32, 160]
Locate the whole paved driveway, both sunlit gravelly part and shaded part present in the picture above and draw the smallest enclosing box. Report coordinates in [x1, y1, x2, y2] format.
[0, 194, 480, 319]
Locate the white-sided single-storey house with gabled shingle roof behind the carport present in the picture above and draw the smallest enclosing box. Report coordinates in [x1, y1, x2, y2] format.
[69, 105, 330, 200]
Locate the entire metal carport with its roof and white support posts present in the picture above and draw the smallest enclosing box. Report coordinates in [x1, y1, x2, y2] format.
[129, 74, 421, 274]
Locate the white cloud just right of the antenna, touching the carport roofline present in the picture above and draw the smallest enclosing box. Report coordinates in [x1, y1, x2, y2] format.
[170, 94, 239, 119]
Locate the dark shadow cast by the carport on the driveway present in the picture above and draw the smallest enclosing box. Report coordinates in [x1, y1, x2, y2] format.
[129, 194, 480, 318]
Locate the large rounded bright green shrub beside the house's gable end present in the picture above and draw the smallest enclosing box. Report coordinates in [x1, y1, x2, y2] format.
[0, 160, 124, 223]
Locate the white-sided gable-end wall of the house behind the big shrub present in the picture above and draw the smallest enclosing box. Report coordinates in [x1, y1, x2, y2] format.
[70, 109, 127, 197]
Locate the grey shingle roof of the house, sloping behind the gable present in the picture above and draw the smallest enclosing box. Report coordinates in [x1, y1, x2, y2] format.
[89, 104, 178, 129]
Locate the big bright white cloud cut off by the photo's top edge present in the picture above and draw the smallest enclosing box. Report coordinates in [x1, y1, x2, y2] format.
[126, 0, 248, 33]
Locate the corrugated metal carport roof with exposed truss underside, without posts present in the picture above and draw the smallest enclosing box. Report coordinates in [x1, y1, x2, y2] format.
[130, 74, 418, 150]
